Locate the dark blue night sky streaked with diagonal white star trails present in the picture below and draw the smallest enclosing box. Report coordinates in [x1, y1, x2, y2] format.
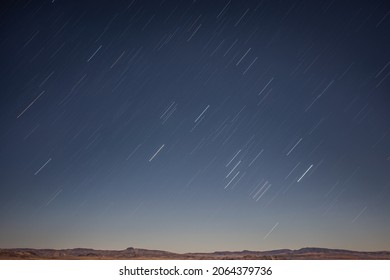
[0, 0, 390, 252]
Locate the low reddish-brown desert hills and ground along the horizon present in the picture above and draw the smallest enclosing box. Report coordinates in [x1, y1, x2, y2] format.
[0, 247, 390, 260]
